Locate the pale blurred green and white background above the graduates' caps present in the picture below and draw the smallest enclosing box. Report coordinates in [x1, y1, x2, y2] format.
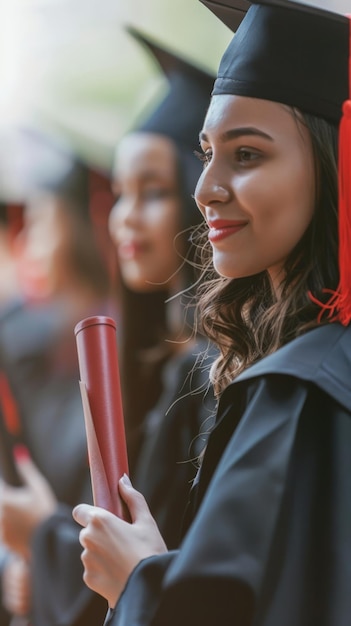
[0, 0, 231, 195]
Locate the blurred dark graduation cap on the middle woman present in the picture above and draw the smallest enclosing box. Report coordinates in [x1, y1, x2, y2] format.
[127, 26, 215, 227]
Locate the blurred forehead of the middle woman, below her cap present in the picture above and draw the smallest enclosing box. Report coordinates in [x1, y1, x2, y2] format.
[114, 133, 176, 177]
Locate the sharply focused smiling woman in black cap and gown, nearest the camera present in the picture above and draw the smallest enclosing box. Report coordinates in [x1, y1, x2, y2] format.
[74, 0, 351, 626]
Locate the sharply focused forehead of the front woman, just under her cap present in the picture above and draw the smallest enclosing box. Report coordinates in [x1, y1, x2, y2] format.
[203, 95, 308, 138]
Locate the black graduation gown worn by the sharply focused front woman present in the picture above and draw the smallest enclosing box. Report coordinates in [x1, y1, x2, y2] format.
[106, 324, 351, 626]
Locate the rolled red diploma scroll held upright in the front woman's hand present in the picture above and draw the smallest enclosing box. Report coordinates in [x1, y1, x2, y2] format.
[74, 316, 129, 520]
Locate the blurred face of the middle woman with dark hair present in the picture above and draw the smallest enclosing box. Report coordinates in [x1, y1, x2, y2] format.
[109, 133, 181, 292]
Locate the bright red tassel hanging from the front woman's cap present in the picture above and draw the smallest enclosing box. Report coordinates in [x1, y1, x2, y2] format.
[309, 16, 351, 326]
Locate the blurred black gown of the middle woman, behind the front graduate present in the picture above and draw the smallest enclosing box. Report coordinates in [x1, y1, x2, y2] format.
[133, 340, 215, 549]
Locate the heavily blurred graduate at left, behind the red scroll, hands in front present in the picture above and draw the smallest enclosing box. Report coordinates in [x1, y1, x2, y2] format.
[0, 137, 115, 626]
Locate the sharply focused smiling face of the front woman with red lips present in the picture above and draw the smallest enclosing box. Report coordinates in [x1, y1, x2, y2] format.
[195, 95, 315, 287]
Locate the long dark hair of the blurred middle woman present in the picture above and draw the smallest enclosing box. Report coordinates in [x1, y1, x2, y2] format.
[118, 145, 204, 472]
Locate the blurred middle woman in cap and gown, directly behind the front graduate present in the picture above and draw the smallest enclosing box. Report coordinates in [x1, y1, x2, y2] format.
[109, 30, 217, 548]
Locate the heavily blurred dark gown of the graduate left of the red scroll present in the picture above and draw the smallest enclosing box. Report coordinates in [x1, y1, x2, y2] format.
[0, 303, 106, 626]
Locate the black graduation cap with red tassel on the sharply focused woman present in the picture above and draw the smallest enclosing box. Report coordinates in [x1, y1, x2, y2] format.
[201, 0, 351, 325]
